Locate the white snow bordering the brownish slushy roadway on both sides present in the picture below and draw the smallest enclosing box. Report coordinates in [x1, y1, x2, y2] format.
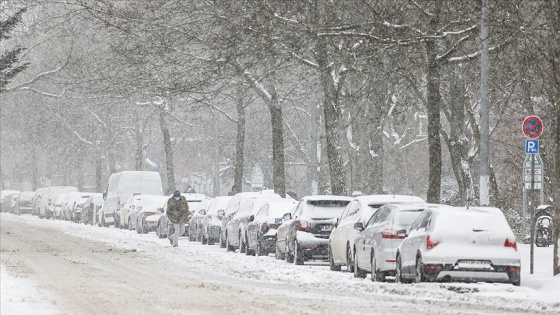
[0, 213, 560, 314]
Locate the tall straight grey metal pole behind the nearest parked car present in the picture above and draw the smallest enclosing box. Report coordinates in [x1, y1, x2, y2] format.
[480, 0, 490, 206]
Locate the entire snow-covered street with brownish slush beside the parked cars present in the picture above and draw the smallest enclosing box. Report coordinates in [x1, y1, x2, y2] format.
[0, 213, 560, 314]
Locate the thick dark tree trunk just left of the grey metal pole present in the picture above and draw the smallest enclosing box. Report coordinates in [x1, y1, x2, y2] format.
[426, 1, 441, 203]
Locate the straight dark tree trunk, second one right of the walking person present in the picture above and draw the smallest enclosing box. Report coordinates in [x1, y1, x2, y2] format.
[268, 105, 286, 197]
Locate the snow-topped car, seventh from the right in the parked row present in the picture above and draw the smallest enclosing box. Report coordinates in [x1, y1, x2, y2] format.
[201, 196, 233, 245]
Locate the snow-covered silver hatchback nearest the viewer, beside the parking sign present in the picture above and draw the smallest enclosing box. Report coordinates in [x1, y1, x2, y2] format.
[396, 207, 521, 286]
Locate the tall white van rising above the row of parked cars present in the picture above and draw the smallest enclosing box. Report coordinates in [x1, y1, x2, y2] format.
[98, 171, 163, 227]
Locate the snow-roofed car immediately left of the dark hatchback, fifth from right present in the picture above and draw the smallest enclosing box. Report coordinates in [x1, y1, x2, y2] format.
[246, 198, 297, 256]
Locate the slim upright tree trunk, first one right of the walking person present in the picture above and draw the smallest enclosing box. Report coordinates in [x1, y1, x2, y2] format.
[232, 82, 245, 194]
